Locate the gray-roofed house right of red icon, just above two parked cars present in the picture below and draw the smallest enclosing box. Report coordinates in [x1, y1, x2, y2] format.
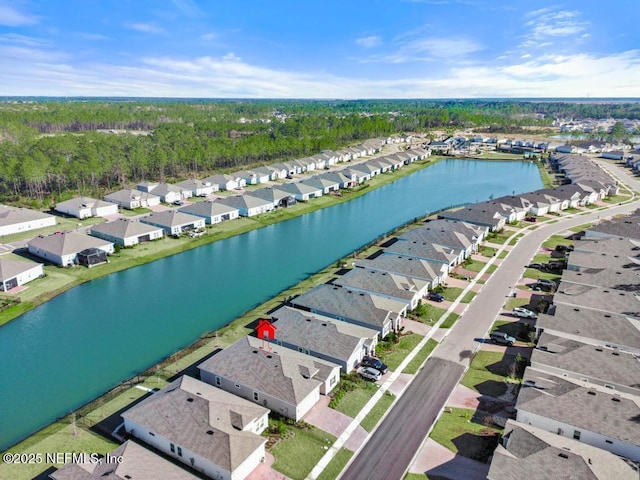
[258, 307, 378, 373]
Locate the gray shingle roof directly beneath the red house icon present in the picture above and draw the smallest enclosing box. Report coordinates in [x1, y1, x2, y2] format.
[198, 337, 339, 405]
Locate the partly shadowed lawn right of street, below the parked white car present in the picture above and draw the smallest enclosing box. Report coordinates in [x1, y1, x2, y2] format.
[461, 348, 515, 397]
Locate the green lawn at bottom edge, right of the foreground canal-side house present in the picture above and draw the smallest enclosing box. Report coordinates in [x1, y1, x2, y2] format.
[271, 426, 336, 480]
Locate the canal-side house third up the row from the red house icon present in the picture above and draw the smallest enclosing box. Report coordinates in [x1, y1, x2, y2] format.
[332, 268, 429, 310]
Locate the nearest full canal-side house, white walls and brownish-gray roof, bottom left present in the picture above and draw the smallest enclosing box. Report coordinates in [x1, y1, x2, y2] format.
[122, 375, 269, 480]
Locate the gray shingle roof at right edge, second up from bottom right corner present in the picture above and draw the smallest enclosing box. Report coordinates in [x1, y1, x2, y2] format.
[516, 367, 640, 445]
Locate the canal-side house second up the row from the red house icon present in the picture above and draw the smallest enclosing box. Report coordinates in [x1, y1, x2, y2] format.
[289, 284, 408, 338]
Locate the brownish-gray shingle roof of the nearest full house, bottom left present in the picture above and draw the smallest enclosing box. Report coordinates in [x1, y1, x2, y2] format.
[122, 376, 268, 471]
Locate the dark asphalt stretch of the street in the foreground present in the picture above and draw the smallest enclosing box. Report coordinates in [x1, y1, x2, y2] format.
[341, 358, 464, 480]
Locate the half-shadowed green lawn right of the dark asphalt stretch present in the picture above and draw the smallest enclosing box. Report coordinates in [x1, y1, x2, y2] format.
[431, 408, 500, 462]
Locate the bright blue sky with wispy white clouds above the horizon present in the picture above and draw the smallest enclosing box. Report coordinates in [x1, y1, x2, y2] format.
[0, 0, 640, 98]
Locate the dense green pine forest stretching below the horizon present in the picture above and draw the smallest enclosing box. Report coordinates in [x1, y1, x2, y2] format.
[0, 98, 640, 206]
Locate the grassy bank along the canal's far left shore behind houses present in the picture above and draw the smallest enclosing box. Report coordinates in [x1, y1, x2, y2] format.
[0, 157, 441, 326]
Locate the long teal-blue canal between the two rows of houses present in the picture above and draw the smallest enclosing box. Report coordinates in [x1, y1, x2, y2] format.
[0, 160, 542, 450]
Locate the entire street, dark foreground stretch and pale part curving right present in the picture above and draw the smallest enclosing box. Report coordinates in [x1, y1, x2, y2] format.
[340, 158, 640, 480]
